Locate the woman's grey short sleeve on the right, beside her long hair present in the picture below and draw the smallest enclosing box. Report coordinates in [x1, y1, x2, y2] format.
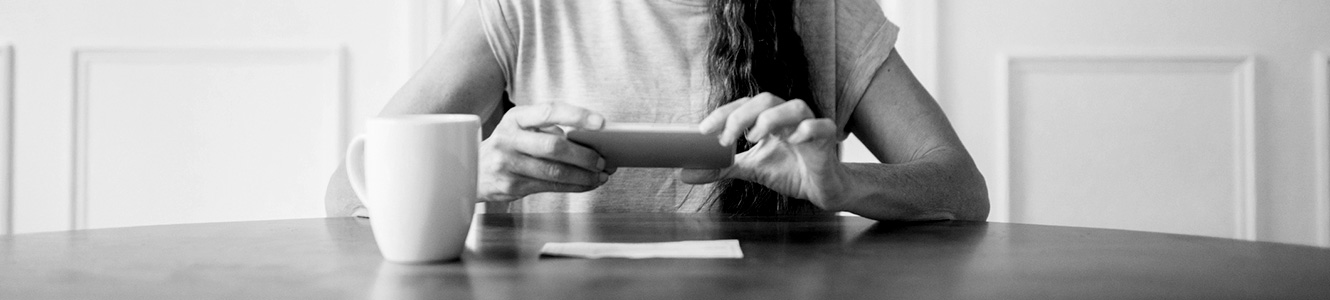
[835, 0, 900, 134]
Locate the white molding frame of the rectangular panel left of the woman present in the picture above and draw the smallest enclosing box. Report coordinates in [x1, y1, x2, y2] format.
[69, 45, 351, 230]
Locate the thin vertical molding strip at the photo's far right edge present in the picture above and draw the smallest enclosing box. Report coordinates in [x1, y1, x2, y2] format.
[1311, 50, 1330, 247]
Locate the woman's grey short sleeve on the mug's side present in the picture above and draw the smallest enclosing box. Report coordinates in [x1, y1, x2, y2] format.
[476, 0, 520, 82]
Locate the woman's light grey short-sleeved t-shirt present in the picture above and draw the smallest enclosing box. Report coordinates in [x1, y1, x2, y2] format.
[477, 0, 899, 212]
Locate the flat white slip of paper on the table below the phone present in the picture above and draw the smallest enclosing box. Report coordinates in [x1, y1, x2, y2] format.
[540, 239, 743, 259]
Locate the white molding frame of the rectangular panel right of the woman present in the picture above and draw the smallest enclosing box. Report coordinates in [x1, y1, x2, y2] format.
[990, 52, 1257, 240]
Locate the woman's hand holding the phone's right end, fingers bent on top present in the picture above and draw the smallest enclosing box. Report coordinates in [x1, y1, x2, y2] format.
[680, 93, 845, 210]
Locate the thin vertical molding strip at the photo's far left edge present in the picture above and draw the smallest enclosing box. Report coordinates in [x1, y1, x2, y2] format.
[0, 44, 15, 235]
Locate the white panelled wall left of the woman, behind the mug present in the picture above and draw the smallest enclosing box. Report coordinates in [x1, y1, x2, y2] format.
[0, 0, 454, 232]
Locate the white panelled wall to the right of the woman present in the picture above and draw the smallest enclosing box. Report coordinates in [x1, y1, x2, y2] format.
[884, 0, 1330, 246]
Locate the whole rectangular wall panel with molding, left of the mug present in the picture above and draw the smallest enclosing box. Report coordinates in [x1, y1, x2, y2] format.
[72, 48, 346, 228]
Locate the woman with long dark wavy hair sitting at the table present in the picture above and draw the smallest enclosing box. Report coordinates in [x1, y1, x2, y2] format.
[327, 0, 988, 220]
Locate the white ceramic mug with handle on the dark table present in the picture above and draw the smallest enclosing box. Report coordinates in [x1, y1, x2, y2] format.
[346, 114, 480, 263]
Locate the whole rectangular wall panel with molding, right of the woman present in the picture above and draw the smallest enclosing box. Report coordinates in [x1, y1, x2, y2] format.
[999, 56, 1256, 238]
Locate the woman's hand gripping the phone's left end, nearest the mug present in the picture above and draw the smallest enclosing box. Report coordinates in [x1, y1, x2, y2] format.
[476, 104, 614, 202]
